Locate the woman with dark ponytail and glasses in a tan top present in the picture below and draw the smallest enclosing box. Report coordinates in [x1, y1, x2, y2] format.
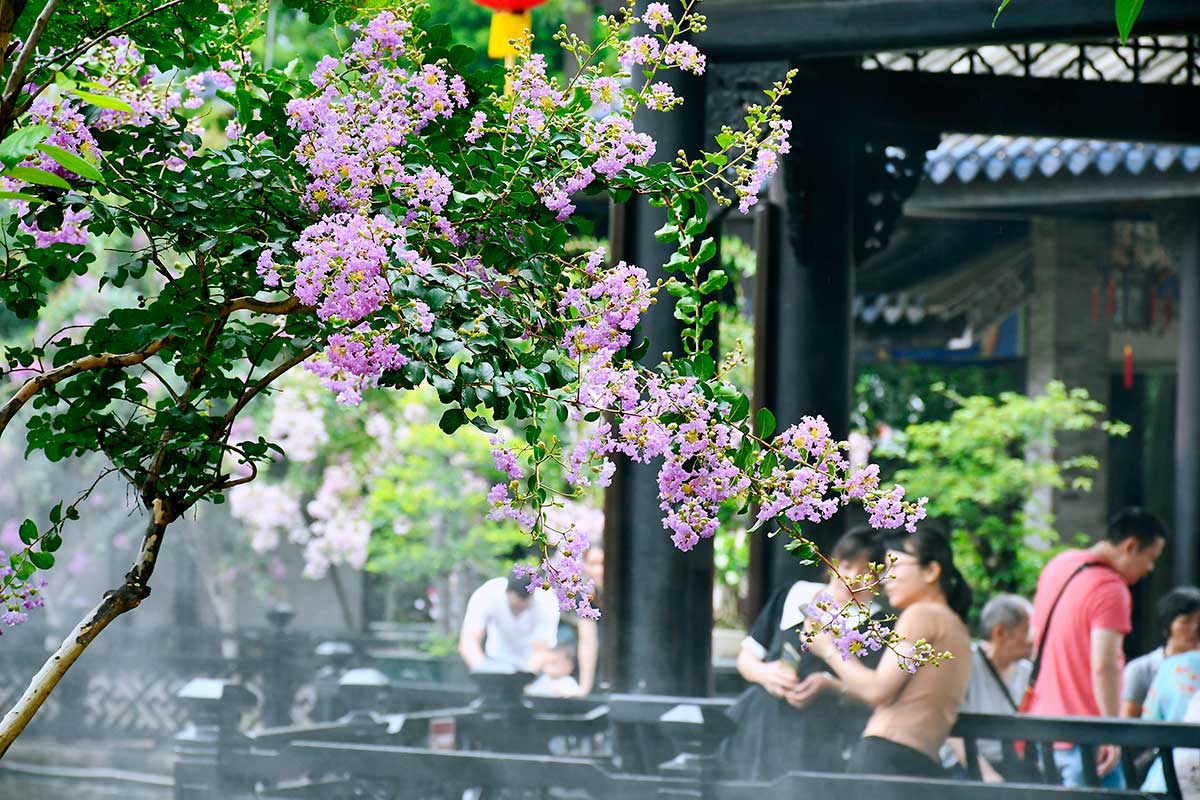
[811, 527, 971, 777]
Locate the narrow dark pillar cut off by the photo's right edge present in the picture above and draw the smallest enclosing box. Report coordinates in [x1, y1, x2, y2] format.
[1170, 203, 1200, 585]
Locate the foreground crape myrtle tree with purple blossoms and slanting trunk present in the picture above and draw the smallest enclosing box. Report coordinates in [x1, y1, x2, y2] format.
[0, 0, 941, 752]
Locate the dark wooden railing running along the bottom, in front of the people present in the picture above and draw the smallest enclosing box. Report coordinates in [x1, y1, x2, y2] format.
[176, 681, 1200, 800]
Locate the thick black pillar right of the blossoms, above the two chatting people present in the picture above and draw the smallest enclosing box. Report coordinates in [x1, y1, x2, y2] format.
[749, 113, 857, 613]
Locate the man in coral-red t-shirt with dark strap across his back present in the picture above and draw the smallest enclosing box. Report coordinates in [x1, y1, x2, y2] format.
[1028, 507, 1166, 788]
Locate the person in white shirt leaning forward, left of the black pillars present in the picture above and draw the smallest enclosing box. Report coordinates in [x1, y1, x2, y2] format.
[458, 577, 558, 673]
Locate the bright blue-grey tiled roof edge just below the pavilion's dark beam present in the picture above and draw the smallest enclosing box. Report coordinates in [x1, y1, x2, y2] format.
[925, 133, 1200, 189]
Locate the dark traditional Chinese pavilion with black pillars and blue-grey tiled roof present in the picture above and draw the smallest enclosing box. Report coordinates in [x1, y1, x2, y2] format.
[605, 0, 1200, 694]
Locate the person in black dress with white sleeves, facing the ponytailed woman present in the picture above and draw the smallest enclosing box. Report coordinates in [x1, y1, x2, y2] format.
[721, 528, 883, 781]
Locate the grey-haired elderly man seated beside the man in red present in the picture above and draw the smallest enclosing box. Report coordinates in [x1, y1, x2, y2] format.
[942, 595, 1033, 783]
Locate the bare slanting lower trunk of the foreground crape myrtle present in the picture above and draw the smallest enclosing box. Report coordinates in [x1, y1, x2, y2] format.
[0, 500, 174, 758]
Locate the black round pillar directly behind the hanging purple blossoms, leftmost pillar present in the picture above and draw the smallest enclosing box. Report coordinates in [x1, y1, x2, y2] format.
[600, 35, 713, 694]
